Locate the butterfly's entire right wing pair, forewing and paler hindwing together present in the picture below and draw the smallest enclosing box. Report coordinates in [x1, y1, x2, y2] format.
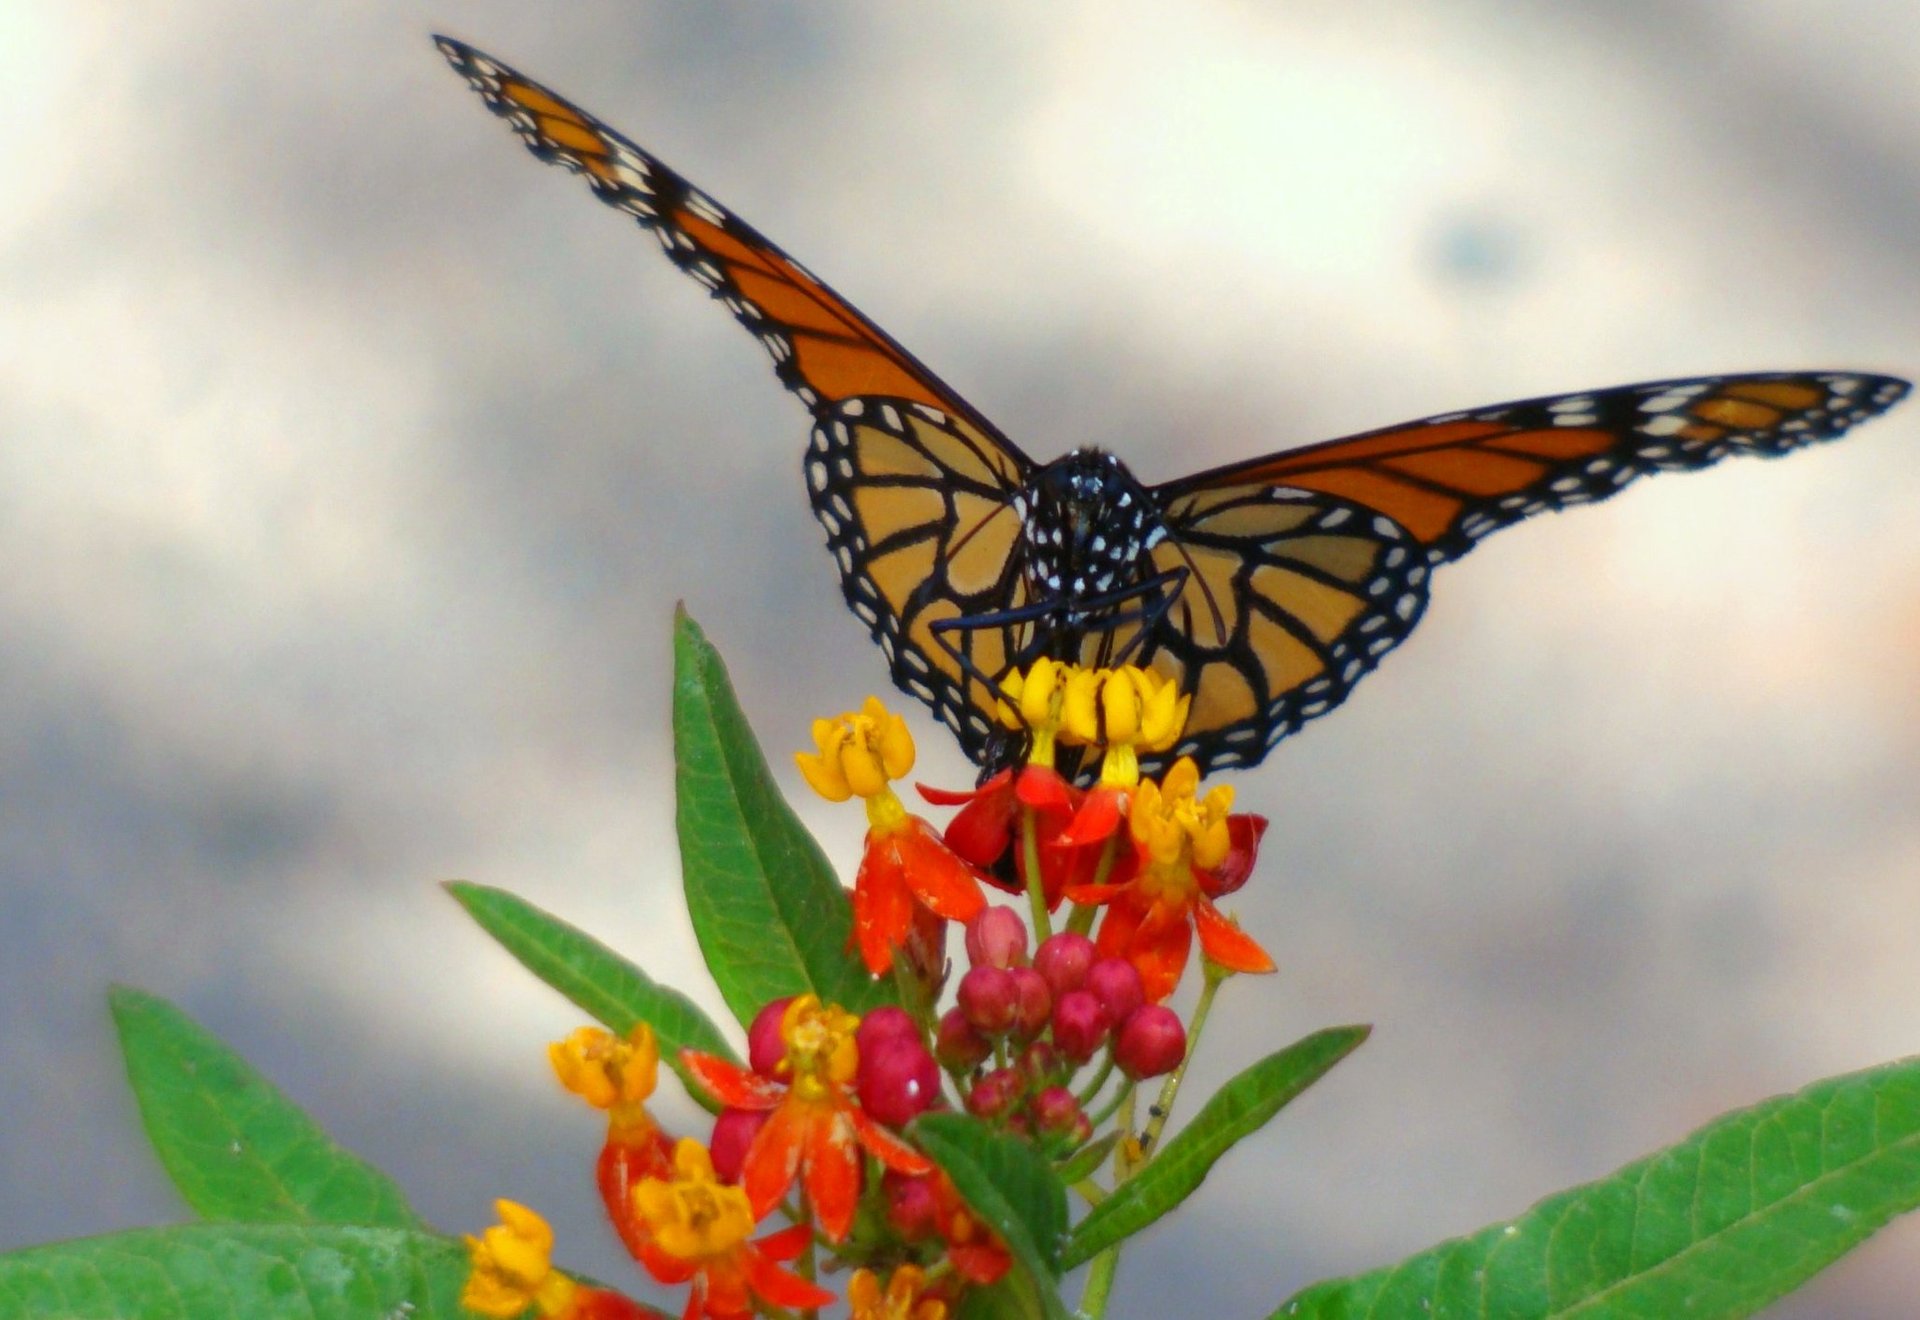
[1152, 372, 1908, 766]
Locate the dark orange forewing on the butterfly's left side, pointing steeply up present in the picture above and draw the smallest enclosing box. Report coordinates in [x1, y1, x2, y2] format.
[434, 36, 1004, 427]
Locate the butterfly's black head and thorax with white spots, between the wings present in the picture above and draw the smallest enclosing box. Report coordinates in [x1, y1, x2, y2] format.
[1021, 449, 1165, 602]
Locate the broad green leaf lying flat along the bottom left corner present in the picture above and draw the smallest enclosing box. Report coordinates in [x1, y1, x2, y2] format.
[0, 1224, 467, 1320]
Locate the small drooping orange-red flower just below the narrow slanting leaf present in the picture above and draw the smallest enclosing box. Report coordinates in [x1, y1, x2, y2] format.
[547, 1023, 674, 1255]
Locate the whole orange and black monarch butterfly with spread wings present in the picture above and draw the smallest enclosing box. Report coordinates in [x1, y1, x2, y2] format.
[436, 36, 1908, 771]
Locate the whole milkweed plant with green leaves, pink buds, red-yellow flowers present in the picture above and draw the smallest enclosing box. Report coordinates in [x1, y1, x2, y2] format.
[11, 614, 1920, 1320]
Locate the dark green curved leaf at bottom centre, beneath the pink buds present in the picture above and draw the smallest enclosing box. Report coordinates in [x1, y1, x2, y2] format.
[908, 1113, 1068, 1320]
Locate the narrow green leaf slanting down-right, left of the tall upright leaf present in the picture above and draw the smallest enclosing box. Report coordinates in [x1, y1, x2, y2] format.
[447, 881, 739, 1101]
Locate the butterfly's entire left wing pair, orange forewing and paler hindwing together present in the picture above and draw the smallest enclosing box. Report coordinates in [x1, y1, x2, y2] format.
[434, 36, 1033, 760]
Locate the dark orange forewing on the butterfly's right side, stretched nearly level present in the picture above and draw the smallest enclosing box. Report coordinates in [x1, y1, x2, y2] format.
[1164, 372, 1908, 564]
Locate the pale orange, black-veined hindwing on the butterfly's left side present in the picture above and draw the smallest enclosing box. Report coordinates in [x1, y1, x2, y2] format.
[806, 399, 1033, 762]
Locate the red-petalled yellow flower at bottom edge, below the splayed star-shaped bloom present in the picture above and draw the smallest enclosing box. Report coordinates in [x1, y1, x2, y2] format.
[634, 1138, 833, 1320]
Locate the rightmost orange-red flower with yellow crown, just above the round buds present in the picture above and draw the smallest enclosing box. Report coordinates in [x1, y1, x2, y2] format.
[1068, 756, 1273, 1003]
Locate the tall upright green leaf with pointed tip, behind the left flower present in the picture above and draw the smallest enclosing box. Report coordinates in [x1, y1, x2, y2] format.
[674, 610, 893, 1025]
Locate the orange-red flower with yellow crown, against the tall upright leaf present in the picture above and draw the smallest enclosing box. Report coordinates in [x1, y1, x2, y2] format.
[793, 696, 987, 977]
